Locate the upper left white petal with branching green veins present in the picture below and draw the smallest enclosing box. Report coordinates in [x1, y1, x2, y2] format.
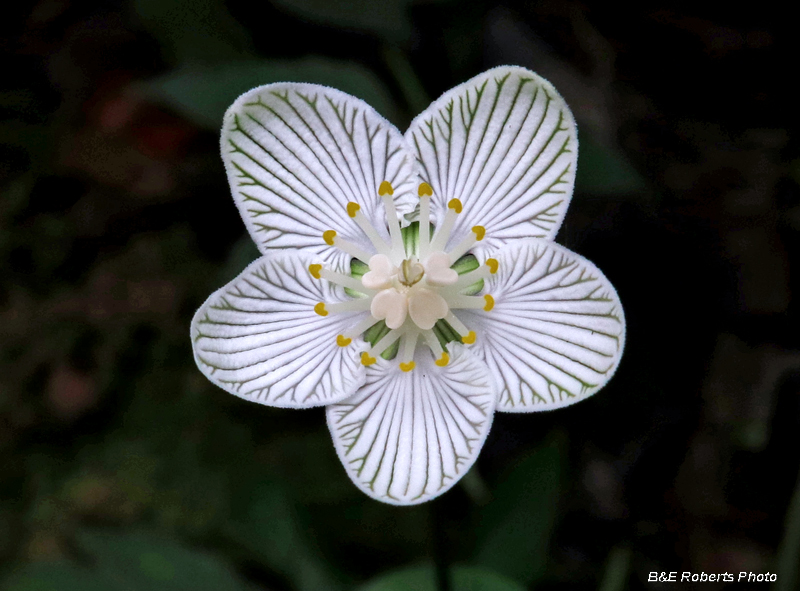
[221, 82, 417, 271]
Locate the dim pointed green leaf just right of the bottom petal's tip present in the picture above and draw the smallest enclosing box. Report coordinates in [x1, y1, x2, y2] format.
[475, 438, 563, 584]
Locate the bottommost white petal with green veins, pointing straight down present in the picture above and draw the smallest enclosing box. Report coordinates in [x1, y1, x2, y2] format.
[327, 344, 497, 505]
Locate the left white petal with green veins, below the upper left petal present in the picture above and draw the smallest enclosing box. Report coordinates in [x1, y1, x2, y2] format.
[192, 252, 365, 408]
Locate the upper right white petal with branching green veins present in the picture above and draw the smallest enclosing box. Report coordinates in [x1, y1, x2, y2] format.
[406, 66, 578, 260]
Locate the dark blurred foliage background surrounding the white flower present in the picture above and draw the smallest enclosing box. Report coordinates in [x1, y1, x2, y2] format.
[0, 0, 800, 591]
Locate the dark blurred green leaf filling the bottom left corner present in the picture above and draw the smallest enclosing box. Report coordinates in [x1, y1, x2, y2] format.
[2, 530, 246, 591]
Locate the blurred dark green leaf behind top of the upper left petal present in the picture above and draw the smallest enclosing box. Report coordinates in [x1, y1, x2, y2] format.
[137, 56, 396, 130]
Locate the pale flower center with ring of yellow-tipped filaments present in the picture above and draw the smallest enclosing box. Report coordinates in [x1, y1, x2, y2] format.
[309, 181, 498, 371]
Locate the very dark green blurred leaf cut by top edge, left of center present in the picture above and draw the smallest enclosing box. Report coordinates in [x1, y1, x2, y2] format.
[133, 0, 254, 63]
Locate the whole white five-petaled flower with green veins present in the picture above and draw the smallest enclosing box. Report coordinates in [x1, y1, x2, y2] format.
[192, 67, 625, 505]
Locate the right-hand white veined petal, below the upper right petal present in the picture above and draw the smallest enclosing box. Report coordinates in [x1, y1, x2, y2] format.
[458, 239, 625, 412]
